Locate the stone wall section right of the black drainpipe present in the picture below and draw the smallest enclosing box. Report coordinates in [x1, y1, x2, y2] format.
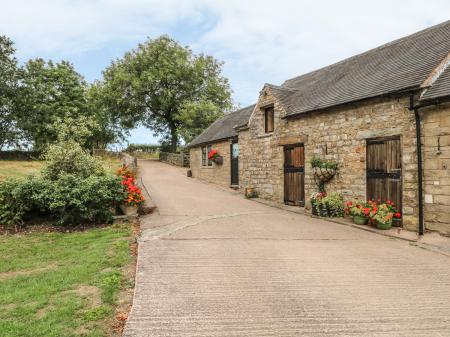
[420, 104, 450, 235]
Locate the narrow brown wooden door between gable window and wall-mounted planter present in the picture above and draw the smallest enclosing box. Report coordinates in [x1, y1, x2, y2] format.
[284, 144, 305, 206]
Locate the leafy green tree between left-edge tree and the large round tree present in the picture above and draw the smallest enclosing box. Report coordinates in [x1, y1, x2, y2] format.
[17, 59, 88, 151]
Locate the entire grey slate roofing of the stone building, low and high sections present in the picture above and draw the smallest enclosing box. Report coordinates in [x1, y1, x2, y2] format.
[189, 20, 450, 146]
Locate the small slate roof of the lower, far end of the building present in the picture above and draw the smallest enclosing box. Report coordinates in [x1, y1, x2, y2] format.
[189, 104, 255, 147]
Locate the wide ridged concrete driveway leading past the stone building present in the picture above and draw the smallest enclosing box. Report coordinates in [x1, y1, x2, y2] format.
[125, 161, 450, 337]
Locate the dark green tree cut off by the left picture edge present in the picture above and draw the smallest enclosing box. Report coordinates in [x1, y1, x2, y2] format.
[0, 35, 18, 150]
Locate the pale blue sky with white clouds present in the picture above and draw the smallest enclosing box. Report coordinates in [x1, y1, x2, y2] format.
[0, 0, 450, 143]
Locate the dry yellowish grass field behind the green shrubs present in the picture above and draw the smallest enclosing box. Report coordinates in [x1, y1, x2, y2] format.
[0, 157, 121, 181]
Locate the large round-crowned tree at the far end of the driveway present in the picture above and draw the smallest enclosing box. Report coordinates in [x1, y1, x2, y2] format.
[103, 36, 231, 152]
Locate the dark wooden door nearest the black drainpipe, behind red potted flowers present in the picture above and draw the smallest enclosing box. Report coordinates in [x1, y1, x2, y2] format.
[367, 137, 402, 212]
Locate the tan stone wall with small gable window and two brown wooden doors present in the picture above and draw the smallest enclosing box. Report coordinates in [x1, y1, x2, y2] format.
[239, 87, 418, 230]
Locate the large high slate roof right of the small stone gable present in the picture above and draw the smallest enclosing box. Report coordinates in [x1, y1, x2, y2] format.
[274, 20, 450, 115]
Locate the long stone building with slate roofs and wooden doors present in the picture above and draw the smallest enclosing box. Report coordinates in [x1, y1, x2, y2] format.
[190, 21, 450, 234]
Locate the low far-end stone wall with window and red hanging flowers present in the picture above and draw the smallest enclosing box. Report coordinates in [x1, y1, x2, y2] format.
[189, 140, 231, 187]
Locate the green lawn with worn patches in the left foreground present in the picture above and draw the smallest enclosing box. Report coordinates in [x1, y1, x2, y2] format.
[0, 225, 132, 337]
